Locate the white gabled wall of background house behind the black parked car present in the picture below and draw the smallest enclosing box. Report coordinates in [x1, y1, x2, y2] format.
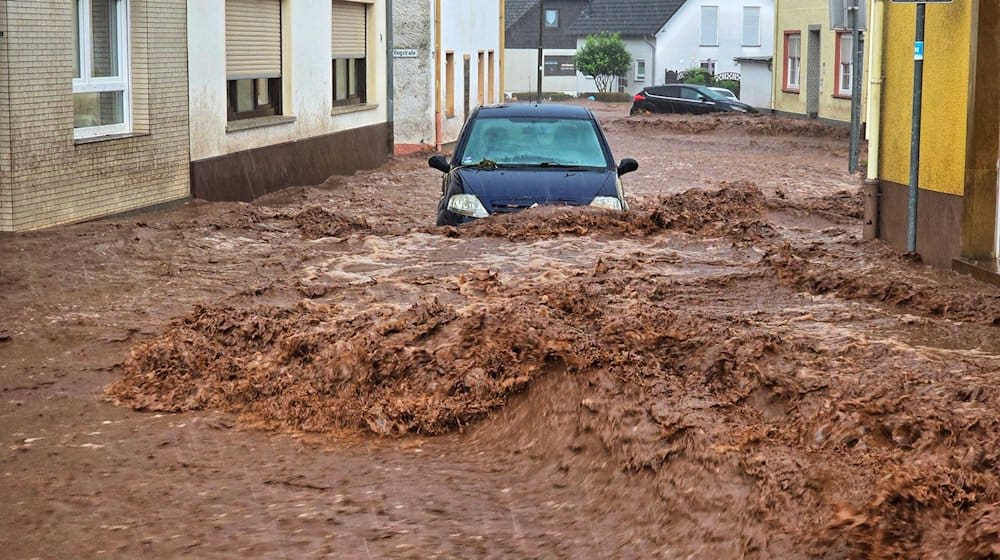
[647, 0, 774, 85]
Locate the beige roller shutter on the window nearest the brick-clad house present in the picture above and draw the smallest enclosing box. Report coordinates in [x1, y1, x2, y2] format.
[226, 0, 281, 80]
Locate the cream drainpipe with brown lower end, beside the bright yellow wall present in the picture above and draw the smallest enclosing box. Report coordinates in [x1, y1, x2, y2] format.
[863, 0, 885, 239]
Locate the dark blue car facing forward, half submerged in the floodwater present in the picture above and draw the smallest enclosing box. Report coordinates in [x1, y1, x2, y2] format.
[428, 104, 639, 225]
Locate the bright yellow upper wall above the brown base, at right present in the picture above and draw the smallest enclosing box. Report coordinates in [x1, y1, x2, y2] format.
[879, 0, 973, 195]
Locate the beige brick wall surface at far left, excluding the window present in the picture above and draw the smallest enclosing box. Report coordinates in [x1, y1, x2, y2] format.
[0, 0, 190, 231]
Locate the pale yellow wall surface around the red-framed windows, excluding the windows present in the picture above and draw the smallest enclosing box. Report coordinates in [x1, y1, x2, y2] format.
[774, 0, 870, 122]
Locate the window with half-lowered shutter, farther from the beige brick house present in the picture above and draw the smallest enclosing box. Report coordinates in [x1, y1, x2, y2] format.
[330, 0, 368, 107]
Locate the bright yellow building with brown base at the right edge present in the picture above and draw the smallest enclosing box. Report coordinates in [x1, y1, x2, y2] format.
[866, 0, 1000, 279]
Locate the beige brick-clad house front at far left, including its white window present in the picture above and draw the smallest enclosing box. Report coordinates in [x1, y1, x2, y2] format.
[0, 0, 190, 231]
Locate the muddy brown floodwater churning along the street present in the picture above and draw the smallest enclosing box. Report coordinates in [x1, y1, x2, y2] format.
[0, 105, 1000, 560]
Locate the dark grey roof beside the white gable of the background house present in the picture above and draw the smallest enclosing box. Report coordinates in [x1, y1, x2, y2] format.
[569, 0, 684, 37]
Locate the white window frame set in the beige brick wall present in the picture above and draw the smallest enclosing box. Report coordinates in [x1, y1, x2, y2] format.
[73, 0, 132, 140]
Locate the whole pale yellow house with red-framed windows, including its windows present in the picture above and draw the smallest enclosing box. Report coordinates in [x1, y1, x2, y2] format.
[773, 0, 870, 123]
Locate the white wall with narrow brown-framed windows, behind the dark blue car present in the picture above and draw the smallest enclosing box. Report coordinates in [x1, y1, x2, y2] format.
[440, 0, 503, 143]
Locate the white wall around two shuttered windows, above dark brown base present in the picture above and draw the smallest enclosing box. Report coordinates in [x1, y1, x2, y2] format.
[187, 0, 387, 161]
